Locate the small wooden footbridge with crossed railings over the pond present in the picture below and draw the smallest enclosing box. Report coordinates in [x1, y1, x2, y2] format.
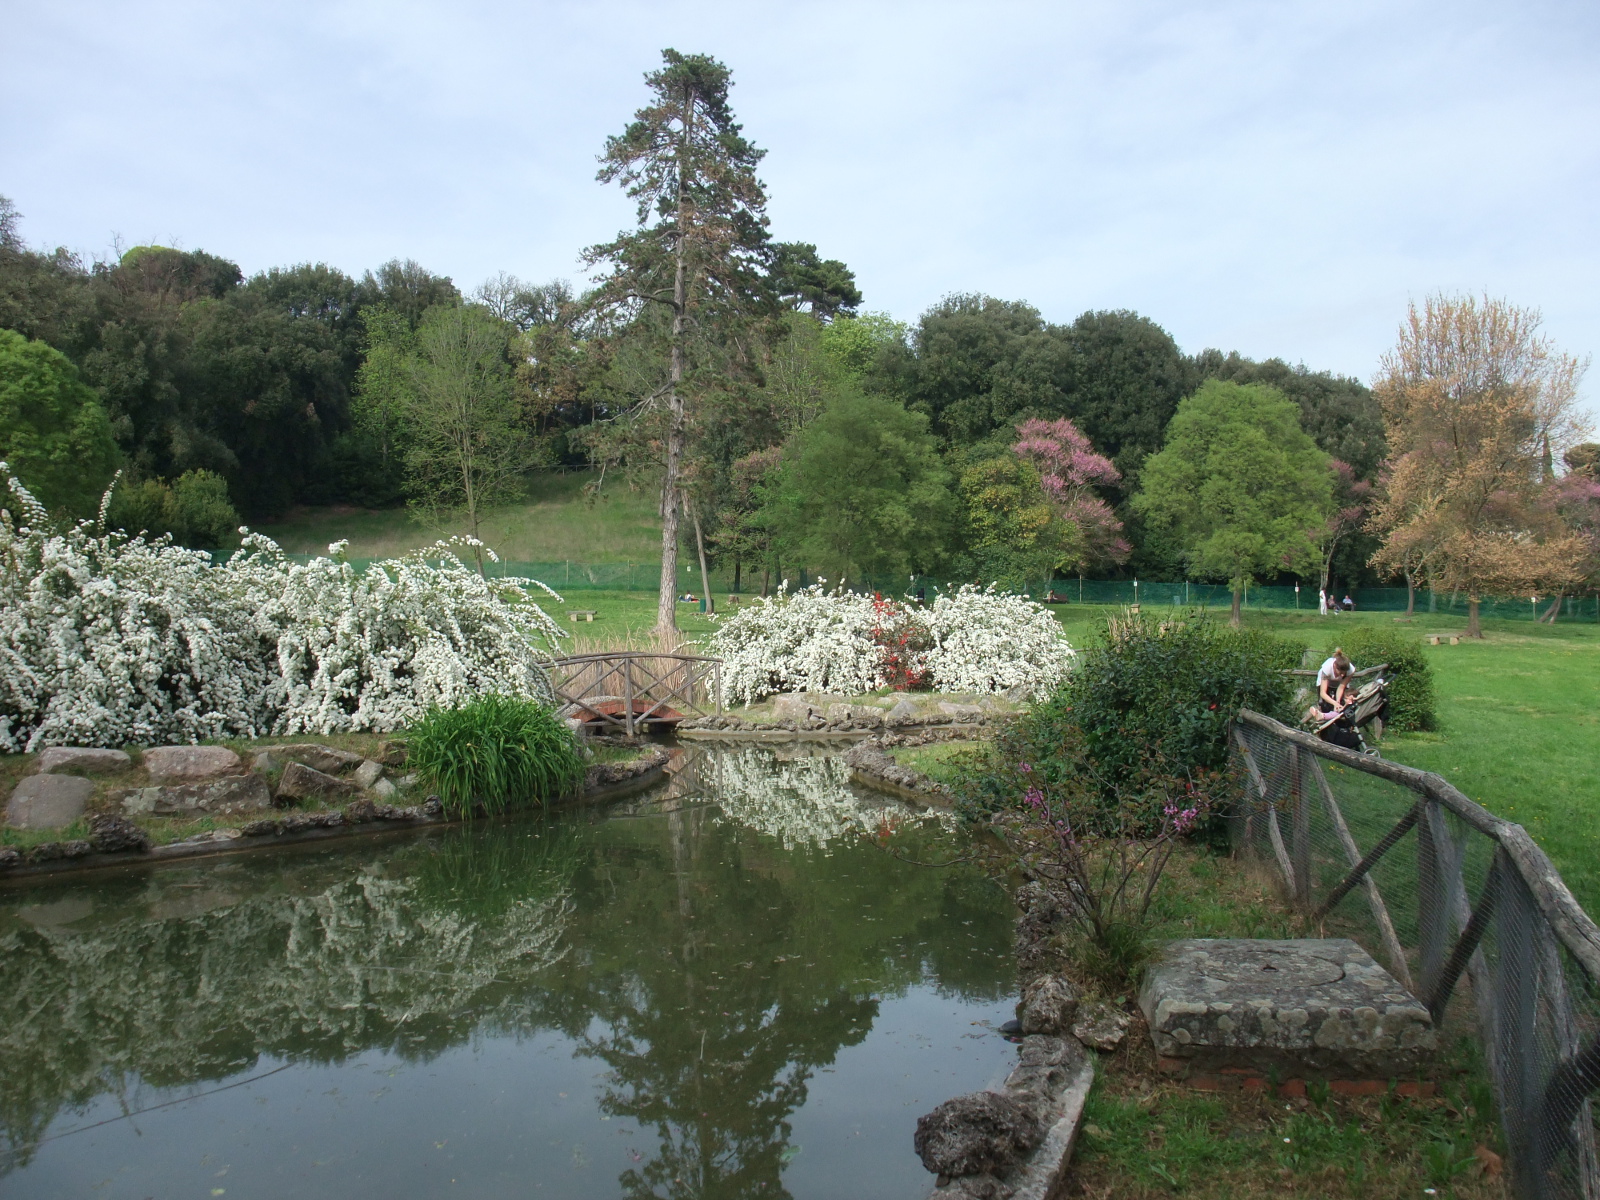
[547, 650, 722, 738]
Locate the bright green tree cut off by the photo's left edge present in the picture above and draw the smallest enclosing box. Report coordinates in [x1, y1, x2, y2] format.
[0, 330, 118, 517]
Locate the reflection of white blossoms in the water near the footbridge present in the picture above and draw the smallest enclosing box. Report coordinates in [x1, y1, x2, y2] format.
[701, 749, 907, 851]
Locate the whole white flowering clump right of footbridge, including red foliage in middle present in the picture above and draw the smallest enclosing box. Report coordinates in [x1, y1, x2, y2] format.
[709, 584, 1074, 704]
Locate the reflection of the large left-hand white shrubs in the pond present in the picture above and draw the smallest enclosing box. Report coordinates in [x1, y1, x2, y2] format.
[0, 864, 573, 1170]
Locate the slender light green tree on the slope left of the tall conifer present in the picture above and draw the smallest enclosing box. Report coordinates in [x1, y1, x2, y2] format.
[398, 304, 534, 574]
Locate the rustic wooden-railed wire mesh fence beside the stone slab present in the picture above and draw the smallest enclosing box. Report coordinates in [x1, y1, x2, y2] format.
[1232, 712, 1600, 1200]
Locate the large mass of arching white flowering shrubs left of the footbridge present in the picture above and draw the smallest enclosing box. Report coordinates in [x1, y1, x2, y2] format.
[0, 464, 562, 754]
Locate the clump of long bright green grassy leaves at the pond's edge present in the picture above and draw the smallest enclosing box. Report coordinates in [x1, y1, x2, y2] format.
[406, 696, 584, 816]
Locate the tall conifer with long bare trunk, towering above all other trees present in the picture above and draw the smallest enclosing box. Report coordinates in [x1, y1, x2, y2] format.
[584, 50, 771, 630]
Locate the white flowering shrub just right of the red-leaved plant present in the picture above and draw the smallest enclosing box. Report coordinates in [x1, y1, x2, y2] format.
[918, 584, 1074, 699]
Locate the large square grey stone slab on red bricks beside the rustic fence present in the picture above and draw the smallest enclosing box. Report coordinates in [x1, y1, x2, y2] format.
[1139, 938, 1437, 1078]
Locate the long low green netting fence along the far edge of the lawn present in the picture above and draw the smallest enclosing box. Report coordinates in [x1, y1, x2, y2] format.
[278, 555, 1600, 621]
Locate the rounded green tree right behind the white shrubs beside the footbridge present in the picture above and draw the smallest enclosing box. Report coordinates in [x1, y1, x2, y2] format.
[764, 392, 950, 579]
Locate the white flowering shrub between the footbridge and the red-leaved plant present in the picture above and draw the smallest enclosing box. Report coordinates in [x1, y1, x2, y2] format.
[709, 582, 883, 704]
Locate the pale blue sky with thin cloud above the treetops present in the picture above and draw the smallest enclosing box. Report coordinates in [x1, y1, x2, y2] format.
[0, 0, 1600, 413]
